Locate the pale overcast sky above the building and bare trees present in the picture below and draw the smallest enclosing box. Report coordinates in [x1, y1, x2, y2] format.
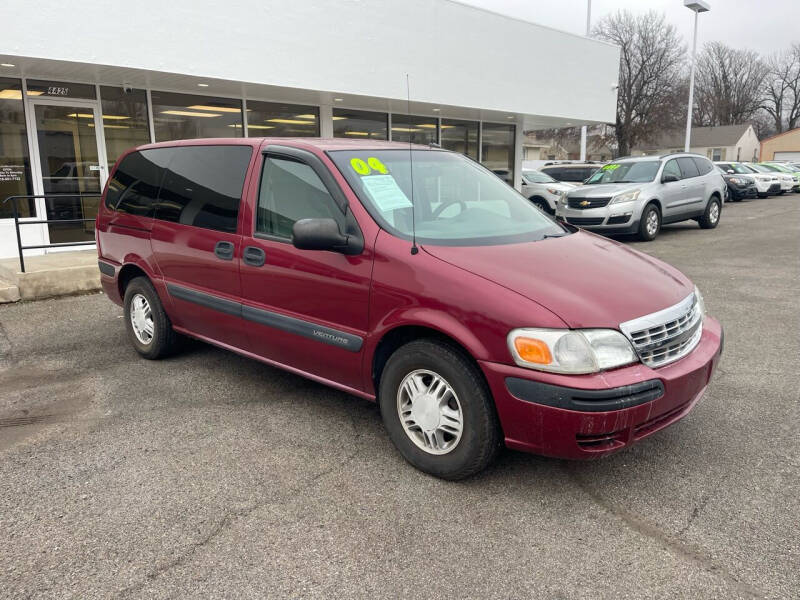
[458, 0, 800, 54]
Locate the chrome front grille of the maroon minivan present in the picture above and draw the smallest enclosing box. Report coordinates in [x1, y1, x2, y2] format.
[620, 294, 703, 368]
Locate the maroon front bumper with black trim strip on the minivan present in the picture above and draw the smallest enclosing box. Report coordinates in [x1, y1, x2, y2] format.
[480, 317, 723, 459]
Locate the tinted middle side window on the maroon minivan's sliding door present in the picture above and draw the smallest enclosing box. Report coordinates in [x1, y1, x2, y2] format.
[156, 146, 253, 233]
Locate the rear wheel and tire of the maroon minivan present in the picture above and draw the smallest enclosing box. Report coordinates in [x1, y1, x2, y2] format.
[124, 277, 178, 360]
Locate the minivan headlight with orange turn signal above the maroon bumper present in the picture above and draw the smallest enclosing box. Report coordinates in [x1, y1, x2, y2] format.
[508, 328, 639, 374]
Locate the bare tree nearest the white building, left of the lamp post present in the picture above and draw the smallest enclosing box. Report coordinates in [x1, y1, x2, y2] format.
[594, 10, 686, 155]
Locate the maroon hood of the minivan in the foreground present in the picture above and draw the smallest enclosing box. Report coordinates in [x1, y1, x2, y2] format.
[424, 231, 694, 328]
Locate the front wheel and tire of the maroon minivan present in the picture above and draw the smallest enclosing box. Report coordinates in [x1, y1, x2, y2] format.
[379, 340, 502, 479]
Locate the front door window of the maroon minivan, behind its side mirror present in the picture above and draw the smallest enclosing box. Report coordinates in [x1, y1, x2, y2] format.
[256, 156, 345, 239]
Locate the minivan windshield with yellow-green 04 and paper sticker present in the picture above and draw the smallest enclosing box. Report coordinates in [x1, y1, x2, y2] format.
[328, 149, 568, 246]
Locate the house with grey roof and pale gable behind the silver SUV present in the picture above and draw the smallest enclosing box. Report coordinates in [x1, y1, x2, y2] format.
[631, 123, 760, 162]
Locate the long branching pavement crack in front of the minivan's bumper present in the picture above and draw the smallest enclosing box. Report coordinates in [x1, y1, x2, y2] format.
[563, 464, 765, 598]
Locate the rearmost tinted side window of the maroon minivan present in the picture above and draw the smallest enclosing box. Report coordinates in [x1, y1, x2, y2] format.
[106, 148, 169, 217]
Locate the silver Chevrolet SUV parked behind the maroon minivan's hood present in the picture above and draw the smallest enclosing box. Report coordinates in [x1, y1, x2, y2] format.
[556, 153, 725, 241]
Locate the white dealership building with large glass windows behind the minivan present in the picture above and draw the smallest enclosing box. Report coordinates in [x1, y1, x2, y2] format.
[0, 0, 619, 258]
